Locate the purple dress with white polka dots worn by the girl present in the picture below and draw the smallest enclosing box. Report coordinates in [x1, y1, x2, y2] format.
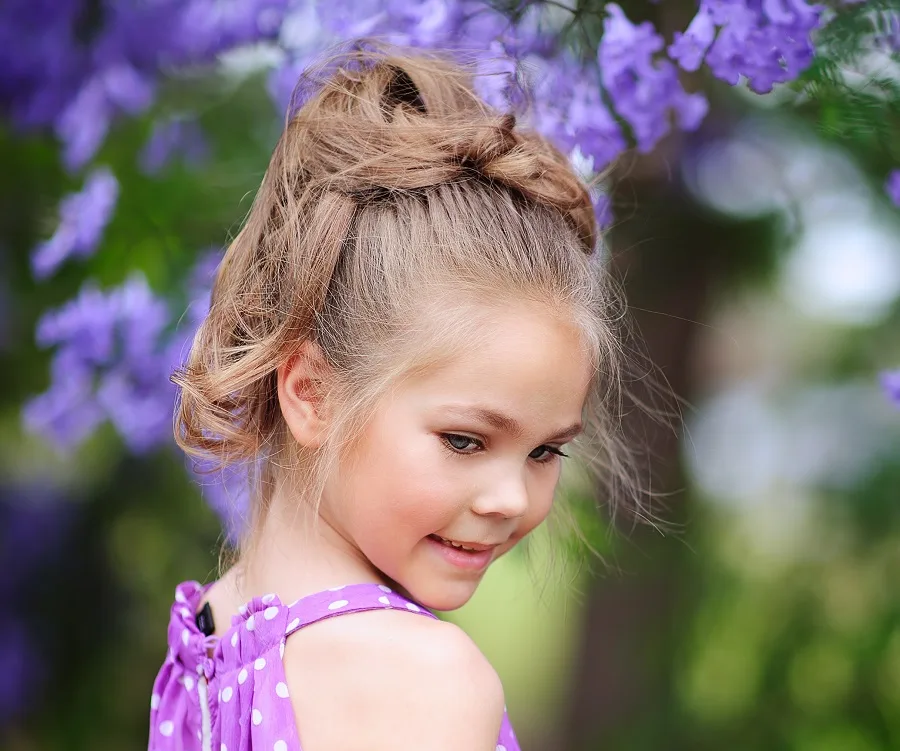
[148, 582, 519, 751]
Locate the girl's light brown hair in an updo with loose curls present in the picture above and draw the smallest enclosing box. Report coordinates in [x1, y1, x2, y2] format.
[173, 44, 660, 560]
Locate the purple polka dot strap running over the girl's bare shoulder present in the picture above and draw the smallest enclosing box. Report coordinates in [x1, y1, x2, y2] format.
[285, 583, 437, 636]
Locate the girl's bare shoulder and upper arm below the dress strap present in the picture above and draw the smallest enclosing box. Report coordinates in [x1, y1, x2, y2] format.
[284, 610, 504, 751]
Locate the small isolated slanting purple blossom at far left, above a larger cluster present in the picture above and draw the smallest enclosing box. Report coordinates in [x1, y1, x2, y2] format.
[31, 167, 119, 279]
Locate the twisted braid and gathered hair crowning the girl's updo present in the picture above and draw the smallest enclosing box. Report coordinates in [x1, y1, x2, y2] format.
[283, 52, 597, 254]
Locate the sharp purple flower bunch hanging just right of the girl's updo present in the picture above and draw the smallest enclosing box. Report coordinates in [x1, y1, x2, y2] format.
[597, 3, 708, 152]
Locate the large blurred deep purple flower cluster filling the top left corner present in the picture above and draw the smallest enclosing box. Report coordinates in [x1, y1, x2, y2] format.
[0, 0, 289, 170]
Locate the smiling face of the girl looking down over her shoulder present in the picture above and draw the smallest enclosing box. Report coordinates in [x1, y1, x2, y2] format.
[320, 307, 592, 610]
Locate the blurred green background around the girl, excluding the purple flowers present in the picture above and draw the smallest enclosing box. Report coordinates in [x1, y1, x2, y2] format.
[0, 2, 900, 751]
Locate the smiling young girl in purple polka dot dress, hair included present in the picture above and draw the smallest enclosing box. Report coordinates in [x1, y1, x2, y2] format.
[150, 44, 640, 751]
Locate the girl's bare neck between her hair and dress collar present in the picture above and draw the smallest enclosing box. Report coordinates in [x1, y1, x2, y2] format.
[229, 493, 386, 602]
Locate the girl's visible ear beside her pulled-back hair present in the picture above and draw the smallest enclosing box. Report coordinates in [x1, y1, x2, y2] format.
[278, 341, 330, 448]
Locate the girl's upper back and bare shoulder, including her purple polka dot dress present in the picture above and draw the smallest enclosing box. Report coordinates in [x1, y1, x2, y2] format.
[149, 582, 519, 751]
